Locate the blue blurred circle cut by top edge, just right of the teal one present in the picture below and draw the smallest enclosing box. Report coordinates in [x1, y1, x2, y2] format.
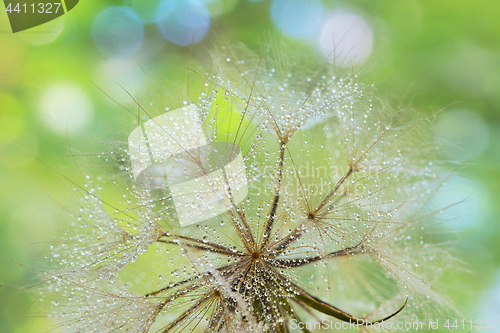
[155, 0, 210, 45]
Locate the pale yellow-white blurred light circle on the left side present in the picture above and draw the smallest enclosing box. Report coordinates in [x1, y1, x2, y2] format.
[38, 84, 93, 135]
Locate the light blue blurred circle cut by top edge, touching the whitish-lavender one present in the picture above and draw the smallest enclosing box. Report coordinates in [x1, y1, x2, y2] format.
[271, 0, 323, 39]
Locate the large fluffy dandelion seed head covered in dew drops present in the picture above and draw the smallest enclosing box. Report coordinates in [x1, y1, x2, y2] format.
[36, 41, 460, 332]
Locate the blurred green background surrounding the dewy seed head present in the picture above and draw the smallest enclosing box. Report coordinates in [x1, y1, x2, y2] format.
[0, 0, 500, 333]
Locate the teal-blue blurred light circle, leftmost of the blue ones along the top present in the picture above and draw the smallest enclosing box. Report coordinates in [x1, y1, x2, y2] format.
[91, 6, 144, 57]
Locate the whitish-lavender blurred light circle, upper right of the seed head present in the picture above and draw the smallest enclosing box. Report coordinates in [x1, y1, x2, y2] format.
[319, 11, 373, 65]
